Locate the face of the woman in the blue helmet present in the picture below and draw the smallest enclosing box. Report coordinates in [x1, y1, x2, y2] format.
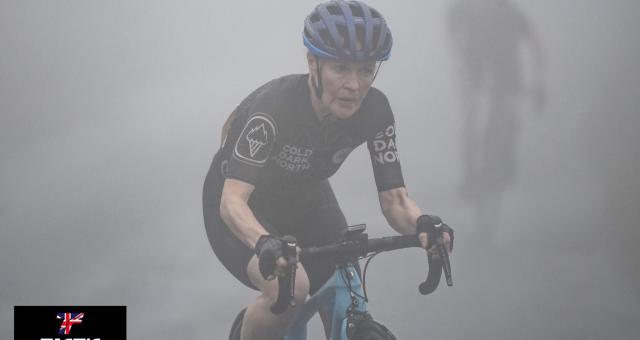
[309, 58, 376, 119]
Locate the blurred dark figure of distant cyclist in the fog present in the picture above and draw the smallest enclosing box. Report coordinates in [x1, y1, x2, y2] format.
[448, 0, 545, 237]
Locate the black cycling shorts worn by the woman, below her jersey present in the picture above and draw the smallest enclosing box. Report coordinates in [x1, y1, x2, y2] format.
[203, 157, 347, 294]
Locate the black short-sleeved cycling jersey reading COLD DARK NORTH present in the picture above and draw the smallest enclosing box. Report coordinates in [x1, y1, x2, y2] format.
[216, 74, 404, 199]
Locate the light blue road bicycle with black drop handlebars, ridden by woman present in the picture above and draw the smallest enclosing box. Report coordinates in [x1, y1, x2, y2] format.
[229, 226, 453, 340]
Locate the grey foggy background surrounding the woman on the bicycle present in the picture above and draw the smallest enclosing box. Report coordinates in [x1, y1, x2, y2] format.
[0, 0, 640, 339]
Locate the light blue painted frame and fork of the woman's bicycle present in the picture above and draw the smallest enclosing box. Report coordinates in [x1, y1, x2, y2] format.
[284, 264, 367, 340]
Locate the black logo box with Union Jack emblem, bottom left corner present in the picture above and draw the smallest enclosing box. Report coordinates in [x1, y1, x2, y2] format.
[13, 306, 127, 340]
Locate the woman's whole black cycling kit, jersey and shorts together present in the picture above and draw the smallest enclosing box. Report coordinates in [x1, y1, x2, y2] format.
[203, 75, 404, 293]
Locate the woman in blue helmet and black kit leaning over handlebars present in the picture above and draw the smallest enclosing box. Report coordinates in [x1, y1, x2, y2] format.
[203, 1, 450, 340]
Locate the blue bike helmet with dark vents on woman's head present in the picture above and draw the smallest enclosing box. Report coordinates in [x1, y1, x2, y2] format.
[303, 0, 393, 61]
